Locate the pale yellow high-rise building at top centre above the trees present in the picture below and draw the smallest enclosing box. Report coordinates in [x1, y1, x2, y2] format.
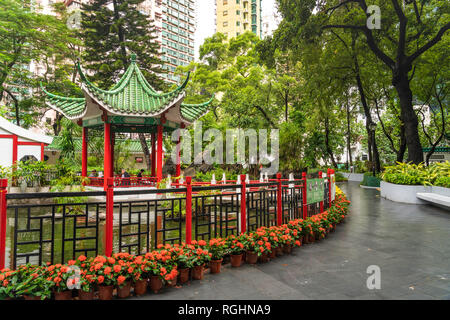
[216, 0, 262, 39]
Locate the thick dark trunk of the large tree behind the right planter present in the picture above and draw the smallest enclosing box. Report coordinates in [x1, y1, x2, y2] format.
[392, 68, 423, 164]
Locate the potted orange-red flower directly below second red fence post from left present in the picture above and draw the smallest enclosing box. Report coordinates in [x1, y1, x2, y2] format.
[90, 256, 116, 300]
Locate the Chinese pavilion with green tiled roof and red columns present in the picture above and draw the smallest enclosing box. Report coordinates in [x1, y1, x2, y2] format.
[42, 54, 213, 187]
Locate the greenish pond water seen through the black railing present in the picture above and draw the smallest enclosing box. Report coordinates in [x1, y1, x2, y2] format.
[5, 206, 243, 267]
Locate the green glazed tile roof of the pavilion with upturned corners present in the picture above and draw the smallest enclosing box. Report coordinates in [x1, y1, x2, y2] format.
[41, 55, 212, 122]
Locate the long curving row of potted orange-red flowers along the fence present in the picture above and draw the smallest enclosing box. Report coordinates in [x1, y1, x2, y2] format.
[0, 194, 350, 300]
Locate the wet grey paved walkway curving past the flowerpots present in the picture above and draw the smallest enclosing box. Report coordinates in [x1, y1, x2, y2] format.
[136, 182, 450, 300]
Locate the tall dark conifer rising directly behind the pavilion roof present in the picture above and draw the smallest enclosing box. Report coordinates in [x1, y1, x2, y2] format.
[81, 0, 164, 170]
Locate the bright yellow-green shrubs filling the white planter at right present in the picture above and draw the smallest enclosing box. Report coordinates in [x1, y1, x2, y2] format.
[381, 161, 450, 187]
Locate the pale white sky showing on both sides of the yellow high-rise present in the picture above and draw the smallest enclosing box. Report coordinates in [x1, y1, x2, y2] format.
[195, 0, 275, 59]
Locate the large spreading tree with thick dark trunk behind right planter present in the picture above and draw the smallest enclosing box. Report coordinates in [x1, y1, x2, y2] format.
[277, 0, 450, 163]
